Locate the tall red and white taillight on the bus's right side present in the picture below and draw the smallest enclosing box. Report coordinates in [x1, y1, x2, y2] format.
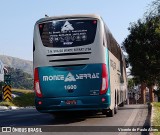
[100, 64, 108, 95]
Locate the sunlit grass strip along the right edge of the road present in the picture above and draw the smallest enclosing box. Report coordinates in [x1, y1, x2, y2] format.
[152, 102, 160, 135]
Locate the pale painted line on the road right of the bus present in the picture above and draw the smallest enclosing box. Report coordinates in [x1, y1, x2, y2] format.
[118, 108, 139, 135]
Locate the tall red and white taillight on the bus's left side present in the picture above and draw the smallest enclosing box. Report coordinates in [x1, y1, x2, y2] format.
[34, 68, 42, 97]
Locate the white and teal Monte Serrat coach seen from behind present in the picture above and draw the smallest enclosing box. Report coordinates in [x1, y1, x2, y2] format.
[33, 15, 127, 117]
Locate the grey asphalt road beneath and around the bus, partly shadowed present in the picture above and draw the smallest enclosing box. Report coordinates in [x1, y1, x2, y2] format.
[0, 105, 150, 135]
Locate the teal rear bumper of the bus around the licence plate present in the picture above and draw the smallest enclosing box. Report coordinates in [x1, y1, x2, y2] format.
[35, 95, 110, 113]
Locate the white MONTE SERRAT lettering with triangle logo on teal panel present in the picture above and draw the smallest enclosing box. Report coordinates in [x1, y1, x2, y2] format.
[43, 72, 99, 82]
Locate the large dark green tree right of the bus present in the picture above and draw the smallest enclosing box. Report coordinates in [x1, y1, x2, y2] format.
[123, 16, 160, 101]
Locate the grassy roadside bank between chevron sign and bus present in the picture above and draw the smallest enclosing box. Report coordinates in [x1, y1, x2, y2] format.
[0, 89, 34, 107]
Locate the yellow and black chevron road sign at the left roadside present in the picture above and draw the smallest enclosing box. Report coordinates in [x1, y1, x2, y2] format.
[3, 85, 12, 101]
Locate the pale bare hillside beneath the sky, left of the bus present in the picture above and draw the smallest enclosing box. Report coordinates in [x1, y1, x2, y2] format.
[0, 55, 33, 75]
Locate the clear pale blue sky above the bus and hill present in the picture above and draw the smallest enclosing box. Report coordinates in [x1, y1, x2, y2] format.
[0, 0, 153, 60]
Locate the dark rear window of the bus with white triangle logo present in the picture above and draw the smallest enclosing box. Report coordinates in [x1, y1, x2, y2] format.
[39, 20, 97, 47]
